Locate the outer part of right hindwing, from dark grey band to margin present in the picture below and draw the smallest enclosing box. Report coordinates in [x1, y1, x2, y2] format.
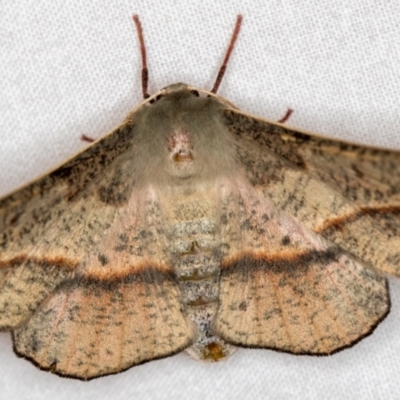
[214, 249, 390, 355]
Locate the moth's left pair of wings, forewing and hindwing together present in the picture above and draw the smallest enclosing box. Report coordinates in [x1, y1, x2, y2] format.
[0, 123, 194, 379]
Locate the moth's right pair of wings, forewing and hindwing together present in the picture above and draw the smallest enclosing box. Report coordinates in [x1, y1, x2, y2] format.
[213, 110, 394, 354]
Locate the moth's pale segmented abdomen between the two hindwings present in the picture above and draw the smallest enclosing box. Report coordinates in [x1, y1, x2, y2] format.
[163, 185, 238, 361]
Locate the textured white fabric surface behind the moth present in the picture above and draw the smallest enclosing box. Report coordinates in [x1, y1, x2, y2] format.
[0, 0, 400, 400]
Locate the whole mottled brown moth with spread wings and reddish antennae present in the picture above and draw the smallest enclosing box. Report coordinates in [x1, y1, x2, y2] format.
[0, 16, 400, 380]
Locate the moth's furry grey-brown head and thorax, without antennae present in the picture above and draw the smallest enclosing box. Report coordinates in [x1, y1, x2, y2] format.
[131, 83, 238, 184]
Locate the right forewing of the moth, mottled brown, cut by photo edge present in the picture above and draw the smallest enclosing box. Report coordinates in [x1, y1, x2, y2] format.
[224, 110, 400, 275]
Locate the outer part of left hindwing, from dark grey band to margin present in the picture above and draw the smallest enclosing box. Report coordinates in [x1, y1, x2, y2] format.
[13, 267, 194, 380]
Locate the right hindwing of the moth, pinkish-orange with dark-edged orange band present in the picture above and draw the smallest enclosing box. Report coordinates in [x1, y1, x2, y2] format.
[213, 181, 389, 354]
